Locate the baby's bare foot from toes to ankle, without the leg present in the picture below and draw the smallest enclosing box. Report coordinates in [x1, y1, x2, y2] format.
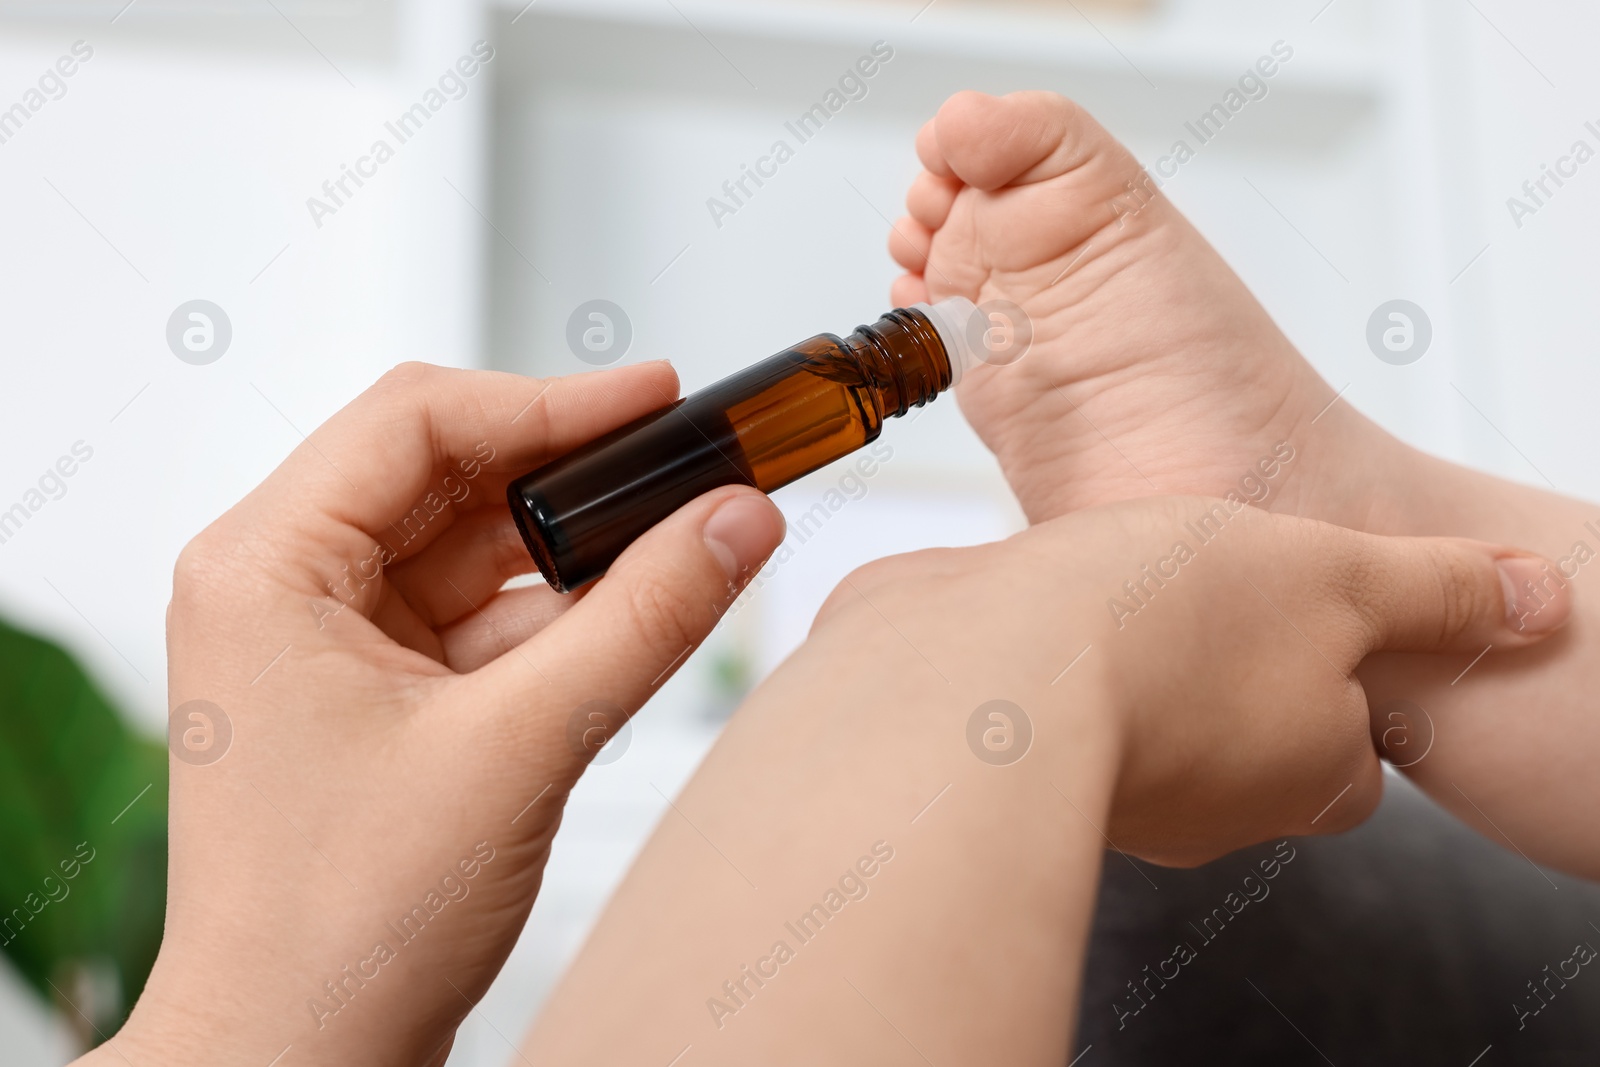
[890, 93, 1400, 528]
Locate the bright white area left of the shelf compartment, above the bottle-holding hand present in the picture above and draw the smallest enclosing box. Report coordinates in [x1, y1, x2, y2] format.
[0, 5, 488, 731]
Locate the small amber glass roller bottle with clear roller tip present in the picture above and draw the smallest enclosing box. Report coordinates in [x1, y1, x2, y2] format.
[507, 298, 981, 592]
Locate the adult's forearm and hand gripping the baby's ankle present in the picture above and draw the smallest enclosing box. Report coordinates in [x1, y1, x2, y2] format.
[525, 498, 1565, 1067]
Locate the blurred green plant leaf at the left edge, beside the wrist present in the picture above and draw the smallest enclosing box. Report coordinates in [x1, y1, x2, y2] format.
[0, 622, 166, 1035]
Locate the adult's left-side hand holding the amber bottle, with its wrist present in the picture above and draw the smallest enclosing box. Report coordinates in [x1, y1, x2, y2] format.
[73, 363, 782, 1067]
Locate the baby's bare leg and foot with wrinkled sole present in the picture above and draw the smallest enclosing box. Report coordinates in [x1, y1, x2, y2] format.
[890, 93, 1600, 877]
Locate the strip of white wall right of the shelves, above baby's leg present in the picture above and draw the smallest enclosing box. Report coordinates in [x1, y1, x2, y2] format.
[1456, 5, 1600, 489]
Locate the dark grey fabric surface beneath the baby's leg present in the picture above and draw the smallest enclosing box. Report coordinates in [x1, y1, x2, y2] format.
[1072, 774, 1600, 1067]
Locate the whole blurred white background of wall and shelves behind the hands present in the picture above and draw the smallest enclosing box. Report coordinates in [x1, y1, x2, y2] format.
[0, 0, 1600, 1065]
